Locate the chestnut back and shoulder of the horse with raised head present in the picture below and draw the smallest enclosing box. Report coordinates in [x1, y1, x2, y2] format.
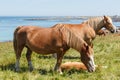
[54, 23, 96, 39]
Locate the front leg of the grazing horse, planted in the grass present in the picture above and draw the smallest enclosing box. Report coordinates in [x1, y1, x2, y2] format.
[54, 53, 64, 74]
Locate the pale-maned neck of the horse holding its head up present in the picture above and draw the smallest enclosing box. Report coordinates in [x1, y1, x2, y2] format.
[85, 17, 104, 32]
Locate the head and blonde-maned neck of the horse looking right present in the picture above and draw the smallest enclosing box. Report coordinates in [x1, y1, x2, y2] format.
[83, 16, 116, 33]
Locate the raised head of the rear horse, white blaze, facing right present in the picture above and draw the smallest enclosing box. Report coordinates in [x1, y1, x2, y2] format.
[104, 16, 116, 33]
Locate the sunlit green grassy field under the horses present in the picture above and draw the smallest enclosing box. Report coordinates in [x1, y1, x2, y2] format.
[0, 35, 120, 80]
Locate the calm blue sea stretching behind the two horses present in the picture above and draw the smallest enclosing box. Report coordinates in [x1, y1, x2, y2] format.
[0, 16, 120, 42]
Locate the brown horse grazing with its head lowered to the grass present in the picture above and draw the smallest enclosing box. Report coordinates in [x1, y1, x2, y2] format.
[13, 24, 95, 73]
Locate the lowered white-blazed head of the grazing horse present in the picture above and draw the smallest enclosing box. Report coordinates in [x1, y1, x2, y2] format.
[80, 44, 95, 72]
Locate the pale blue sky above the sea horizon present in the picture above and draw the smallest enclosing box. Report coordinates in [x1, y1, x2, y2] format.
[0, 0, 120, 16]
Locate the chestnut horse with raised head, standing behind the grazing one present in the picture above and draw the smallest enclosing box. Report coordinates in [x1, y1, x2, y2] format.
[52, 16, 116, 45]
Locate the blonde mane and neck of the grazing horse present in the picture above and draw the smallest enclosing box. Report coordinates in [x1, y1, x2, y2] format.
[53, 24, 87, 51]
